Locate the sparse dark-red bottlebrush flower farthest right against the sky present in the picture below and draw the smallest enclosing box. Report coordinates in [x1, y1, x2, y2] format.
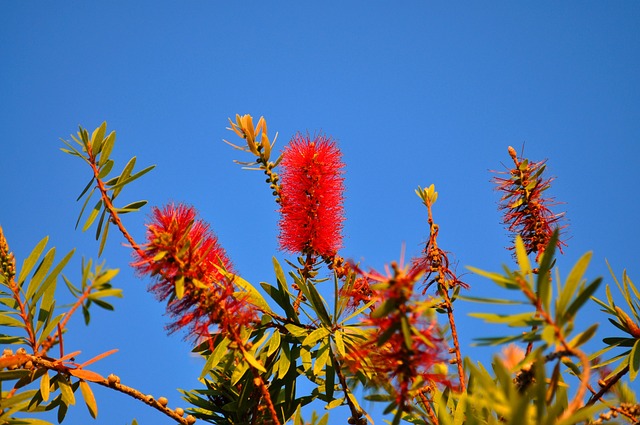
[494, 146, 566, 259]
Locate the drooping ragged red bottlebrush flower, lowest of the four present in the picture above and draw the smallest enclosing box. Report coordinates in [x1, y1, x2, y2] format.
[345, 263, 451, 410]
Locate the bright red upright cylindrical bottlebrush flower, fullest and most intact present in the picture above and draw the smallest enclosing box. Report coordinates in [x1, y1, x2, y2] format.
[279, 133, 344, 258]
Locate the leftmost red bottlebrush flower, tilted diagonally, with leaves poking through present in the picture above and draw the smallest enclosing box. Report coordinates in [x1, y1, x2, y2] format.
[133, 204, 256, 337]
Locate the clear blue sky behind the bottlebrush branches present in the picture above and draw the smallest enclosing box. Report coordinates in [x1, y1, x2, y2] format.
[0, 1, 640, 424]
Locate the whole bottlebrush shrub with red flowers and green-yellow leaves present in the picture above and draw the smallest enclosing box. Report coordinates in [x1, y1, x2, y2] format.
[0, 115, 640, 425]
